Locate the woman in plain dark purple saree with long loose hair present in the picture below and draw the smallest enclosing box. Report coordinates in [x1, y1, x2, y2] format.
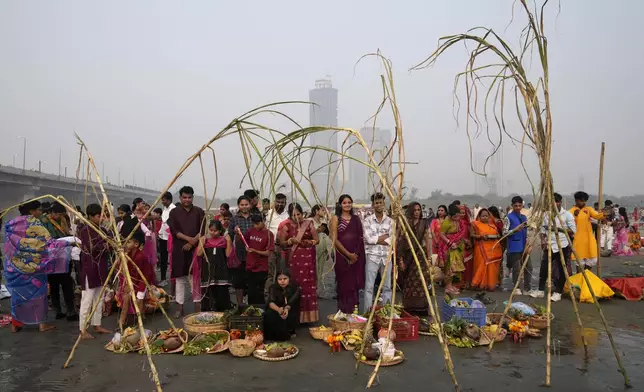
[331, 195, 365, 313]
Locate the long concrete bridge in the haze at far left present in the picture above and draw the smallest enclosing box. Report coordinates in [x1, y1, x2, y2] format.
[0, 166, 160, 217]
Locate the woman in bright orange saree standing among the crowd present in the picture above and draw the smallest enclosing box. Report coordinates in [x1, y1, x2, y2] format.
[472, 208, 503, 291]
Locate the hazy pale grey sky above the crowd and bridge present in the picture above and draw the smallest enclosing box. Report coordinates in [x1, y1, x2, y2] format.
[0, 0, 644, 201]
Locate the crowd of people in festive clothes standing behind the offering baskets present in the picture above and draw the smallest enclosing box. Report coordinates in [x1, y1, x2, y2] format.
[5, 186, 641, 340]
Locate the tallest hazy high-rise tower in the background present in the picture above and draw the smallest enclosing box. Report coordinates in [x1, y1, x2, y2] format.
[309, 77, 340, 204]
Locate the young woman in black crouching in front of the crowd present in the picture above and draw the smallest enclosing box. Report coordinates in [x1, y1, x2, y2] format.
[264, 271, 300, 341]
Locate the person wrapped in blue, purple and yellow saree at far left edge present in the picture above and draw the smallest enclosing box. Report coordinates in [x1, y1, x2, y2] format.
[4, 201, 74, 332]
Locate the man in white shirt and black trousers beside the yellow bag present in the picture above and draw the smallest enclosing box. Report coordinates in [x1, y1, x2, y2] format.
[528, 193, 577, 302]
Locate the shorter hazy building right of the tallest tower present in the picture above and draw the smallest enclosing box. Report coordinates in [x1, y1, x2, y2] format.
[345, 127, 392, 200]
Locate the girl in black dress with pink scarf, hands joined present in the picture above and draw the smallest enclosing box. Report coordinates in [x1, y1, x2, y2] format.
[197, 220, 232, 312]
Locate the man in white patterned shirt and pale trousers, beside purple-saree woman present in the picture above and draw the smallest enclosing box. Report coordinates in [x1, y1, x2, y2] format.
[362, 193, 393, 312]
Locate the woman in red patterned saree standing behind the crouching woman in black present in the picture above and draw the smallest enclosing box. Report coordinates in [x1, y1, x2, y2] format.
[277, 203, 320, 323]
